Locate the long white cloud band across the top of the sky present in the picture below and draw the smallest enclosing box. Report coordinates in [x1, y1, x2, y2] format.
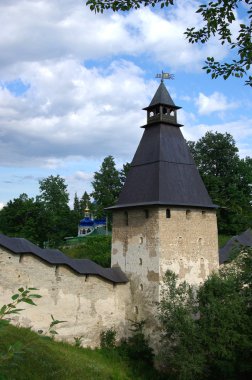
[0, 0, 230, 75]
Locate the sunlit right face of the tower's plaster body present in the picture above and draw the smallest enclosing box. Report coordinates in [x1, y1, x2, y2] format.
[159, 208, 219, 285]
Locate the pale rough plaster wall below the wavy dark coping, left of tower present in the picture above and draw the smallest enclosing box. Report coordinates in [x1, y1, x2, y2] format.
[0, 248, 130, 347]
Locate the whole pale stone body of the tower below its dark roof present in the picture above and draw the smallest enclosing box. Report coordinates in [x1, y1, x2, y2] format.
[111, 206, 219, 346]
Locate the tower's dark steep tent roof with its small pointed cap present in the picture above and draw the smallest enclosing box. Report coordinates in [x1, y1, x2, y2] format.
[108, 82, 216, 209]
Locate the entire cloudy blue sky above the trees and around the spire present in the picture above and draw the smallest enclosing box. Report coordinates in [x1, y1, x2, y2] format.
[0, 0, 252, 207]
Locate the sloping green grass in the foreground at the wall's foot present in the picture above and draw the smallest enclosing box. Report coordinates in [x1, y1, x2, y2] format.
[0, 325, 161, 380]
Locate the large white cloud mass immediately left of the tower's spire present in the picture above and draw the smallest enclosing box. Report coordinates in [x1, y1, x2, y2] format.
[0, 60, 149, 168]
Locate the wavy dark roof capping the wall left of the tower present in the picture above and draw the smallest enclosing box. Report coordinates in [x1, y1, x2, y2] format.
[0, 234, 128, 283]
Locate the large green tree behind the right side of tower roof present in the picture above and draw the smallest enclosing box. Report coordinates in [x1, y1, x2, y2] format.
[188, 132, 252, 234]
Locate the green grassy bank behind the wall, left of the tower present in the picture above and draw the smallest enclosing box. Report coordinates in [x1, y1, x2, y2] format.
[59, 235, 111, 268]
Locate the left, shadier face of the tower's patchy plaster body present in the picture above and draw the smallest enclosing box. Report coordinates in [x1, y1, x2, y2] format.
[111, 208, 160, 331]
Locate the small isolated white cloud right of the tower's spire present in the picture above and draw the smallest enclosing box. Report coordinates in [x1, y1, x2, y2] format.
[195, 91, 238, 115]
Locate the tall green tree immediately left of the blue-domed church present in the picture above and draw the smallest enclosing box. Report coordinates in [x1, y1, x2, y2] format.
[37, 175, 72, 246]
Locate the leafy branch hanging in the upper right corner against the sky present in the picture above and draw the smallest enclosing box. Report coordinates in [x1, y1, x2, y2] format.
[185, 0, 252, 86]
